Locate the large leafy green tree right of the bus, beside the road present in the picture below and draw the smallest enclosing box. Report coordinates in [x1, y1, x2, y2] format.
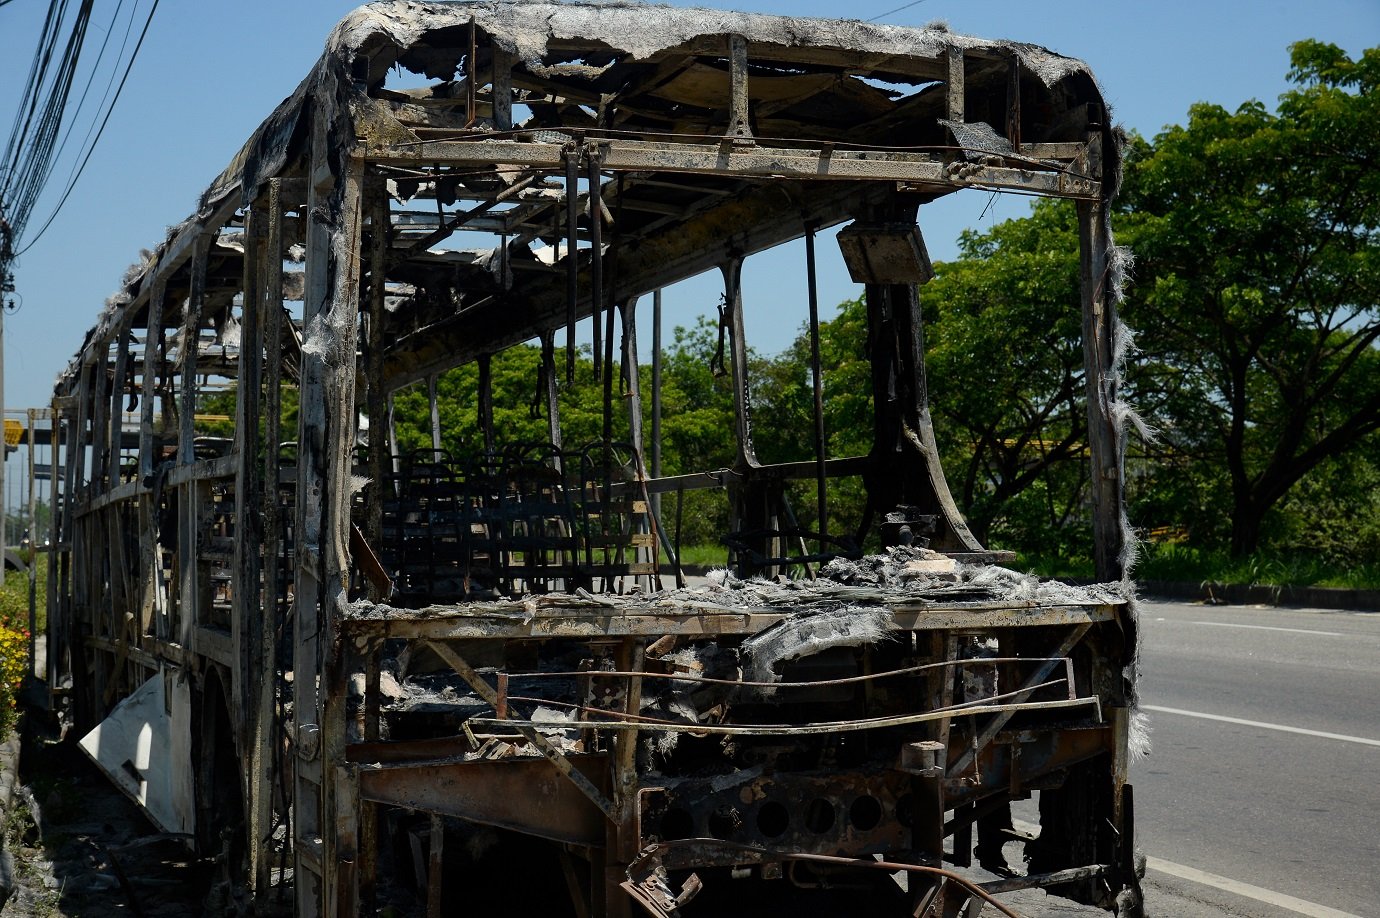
[1119, 41, 1380, 555]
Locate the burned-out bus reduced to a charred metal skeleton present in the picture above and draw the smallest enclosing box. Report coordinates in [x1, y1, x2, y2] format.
[48, 1, 1139, 915]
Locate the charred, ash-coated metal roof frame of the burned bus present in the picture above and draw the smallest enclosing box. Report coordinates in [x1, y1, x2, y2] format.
[58, 1, 1115, 392]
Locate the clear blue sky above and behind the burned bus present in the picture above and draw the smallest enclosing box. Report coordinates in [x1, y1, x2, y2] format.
[0, 0, 1380, 419]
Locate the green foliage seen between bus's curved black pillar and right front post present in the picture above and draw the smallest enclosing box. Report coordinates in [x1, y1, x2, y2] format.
[920, 200, 1087, 551]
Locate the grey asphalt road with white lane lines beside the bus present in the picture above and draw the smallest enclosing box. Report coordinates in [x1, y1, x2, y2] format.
[1132, 602, 1380, 918]
